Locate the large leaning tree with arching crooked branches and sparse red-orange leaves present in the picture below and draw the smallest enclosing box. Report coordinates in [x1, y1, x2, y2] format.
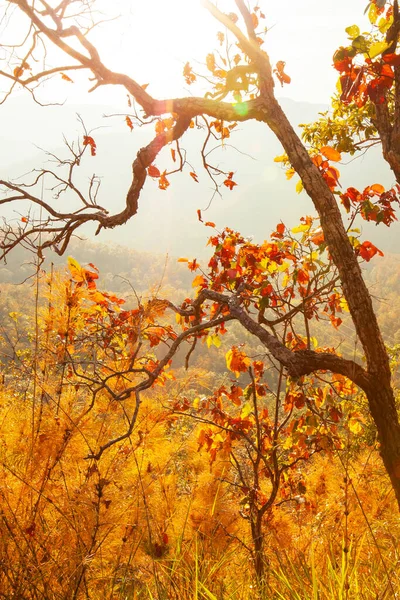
[0, 0, 400, 505]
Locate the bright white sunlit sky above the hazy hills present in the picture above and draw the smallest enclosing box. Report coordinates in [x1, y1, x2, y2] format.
[2, 0, 369, 104]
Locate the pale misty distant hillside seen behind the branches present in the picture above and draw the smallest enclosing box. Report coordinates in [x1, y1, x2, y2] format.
[0, 97, 400, 256]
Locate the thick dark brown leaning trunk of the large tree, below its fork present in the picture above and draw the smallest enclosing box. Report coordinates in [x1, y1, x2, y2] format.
[258, 93, 400, 509]
